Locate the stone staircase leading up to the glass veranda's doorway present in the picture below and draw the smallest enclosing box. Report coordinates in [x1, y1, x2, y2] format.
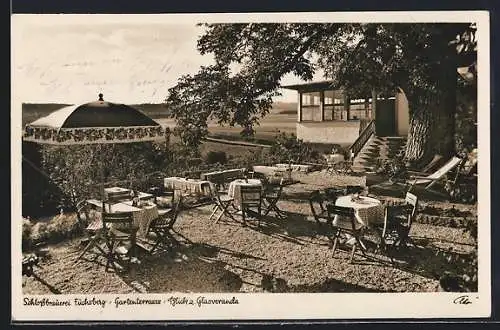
[352, 135, 406, 173]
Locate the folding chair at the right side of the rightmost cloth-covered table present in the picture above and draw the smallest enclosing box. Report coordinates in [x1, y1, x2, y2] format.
[381, 192, 418, 254]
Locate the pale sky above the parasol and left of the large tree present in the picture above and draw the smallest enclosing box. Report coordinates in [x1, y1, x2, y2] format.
[12, 15, 312, 104]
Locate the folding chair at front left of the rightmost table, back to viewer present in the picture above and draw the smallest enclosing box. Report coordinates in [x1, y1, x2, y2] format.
[326, 204, 366, 263]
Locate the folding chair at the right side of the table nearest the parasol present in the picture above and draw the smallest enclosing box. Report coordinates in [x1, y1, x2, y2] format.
[148, 194, 182, 254]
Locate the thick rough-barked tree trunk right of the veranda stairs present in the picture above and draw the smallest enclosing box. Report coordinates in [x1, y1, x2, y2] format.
[405, 65, 457, 166]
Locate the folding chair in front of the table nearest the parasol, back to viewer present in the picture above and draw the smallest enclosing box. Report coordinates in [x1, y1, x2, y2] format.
[102, 212, 139, 272]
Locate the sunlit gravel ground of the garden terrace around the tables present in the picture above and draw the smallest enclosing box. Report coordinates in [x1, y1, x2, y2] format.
[23, 172, 474, 294]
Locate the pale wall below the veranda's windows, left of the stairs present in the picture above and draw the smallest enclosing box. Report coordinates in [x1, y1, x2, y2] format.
[297, 120, 359, 145]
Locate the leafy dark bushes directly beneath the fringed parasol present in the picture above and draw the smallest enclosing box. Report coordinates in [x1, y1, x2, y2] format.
[23, 142, 171, 215]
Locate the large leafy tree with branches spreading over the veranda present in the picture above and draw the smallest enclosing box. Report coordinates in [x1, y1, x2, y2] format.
[166, 23, 476, 159]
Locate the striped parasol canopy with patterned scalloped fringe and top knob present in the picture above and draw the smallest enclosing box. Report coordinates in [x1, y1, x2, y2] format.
[23, 94, 168, 145]
